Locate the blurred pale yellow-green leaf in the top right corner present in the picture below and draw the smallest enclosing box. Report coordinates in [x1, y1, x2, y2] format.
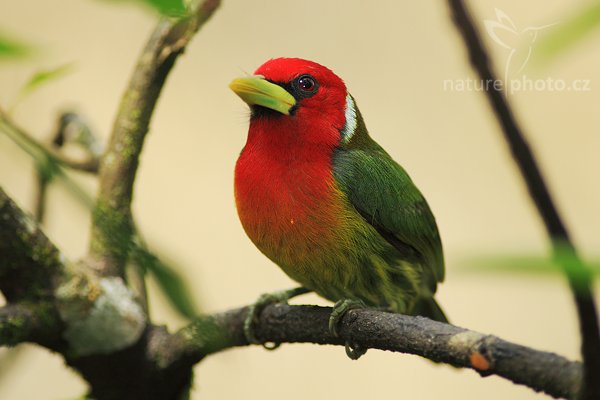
[536, 0, 600, 63]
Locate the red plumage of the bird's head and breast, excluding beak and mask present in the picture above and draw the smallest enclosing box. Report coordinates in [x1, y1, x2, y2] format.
[235, 59, 347, 264]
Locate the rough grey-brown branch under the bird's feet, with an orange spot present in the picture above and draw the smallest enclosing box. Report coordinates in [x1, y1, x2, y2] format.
[163, 304, 582, 399]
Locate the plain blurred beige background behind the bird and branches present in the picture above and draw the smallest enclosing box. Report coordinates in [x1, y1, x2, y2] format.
[0, 0, 600, 400]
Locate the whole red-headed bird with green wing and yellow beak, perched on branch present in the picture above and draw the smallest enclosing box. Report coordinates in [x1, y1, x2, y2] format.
[230, 57, 448, 358]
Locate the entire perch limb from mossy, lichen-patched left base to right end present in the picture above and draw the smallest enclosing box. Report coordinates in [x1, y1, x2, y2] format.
[0, 189, 582, 399]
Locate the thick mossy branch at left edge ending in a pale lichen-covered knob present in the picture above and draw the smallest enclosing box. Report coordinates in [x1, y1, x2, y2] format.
[0, 188, 148, 358]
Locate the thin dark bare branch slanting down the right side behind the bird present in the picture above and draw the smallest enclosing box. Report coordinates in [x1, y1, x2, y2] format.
[448, 0, 600, 400]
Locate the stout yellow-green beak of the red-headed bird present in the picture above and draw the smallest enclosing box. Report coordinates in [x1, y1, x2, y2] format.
[229, 75, 296, 115]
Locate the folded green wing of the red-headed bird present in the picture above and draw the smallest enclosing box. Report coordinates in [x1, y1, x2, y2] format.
[333, 142, 444, 293]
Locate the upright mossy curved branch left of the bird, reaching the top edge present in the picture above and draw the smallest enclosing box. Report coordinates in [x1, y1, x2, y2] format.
[91, 0, 220, 276]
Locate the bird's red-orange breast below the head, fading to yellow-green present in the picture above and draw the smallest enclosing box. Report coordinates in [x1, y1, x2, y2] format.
[235, 99, 341, 266]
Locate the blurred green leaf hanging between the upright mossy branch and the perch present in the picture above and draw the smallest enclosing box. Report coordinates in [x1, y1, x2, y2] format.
[132, 242, 199, 319]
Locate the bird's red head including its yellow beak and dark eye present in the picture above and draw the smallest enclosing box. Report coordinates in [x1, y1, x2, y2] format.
[230, 58, 354, 148]
